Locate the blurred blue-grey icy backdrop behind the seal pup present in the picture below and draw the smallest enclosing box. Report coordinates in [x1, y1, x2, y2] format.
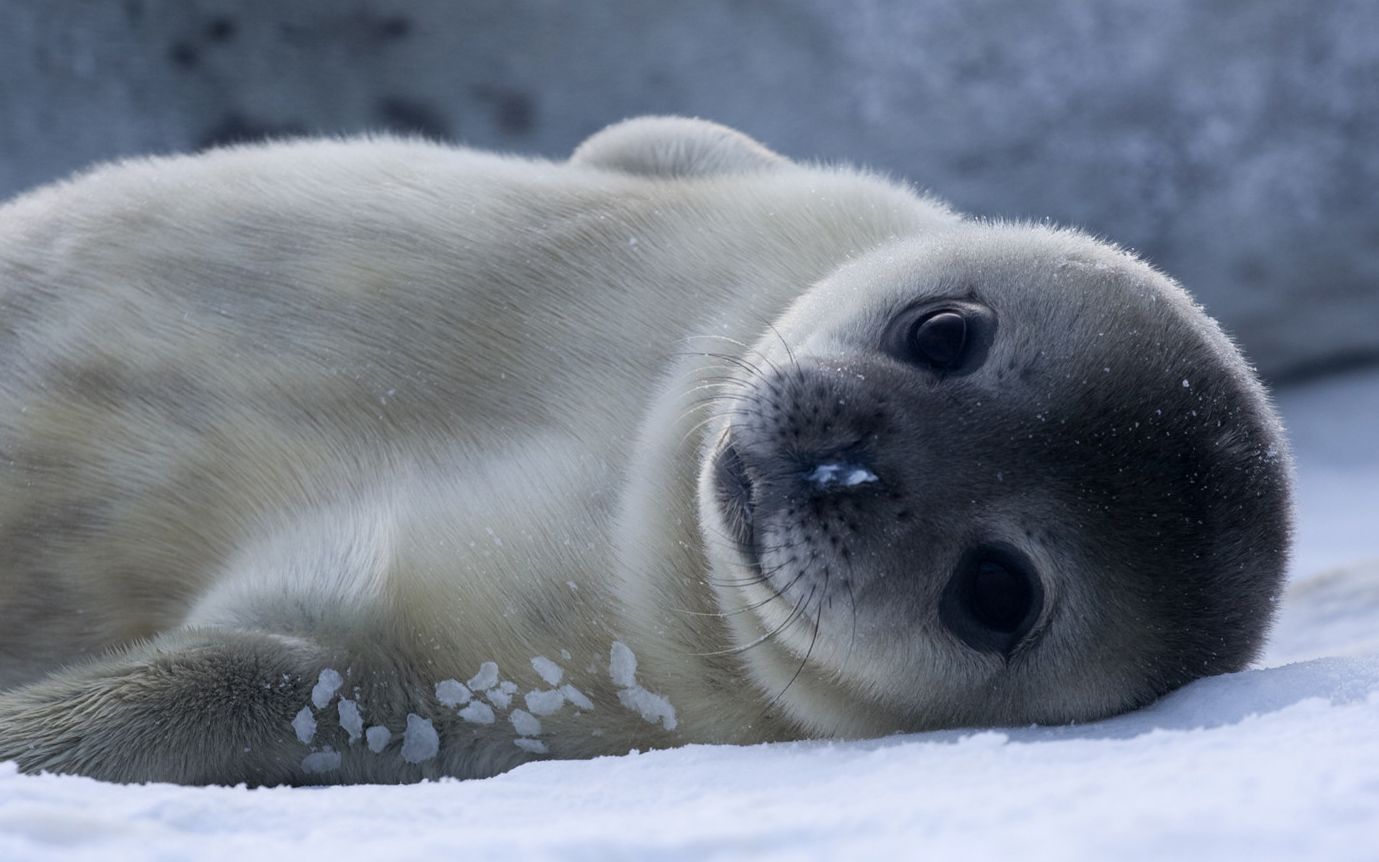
[0, 0, 1379, 570]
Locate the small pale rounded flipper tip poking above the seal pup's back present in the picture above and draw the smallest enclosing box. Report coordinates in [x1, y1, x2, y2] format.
[570, 117, 790, 179]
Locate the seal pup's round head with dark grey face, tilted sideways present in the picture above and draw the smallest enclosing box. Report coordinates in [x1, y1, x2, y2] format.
[701, 225, 1289, 727]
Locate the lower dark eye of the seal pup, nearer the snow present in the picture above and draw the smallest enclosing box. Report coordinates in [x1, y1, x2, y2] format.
[939, 548, 1044, 654]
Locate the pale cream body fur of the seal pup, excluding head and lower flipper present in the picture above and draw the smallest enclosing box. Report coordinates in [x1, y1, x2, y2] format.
[0, 120, 953, 776]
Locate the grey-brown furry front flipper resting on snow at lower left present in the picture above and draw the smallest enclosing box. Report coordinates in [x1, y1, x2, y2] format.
[0, 629, 336, 785]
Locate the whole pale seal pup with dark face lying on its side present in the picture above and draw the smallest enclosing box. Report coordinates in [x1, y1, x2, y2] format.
[0, 117, 1289, 785]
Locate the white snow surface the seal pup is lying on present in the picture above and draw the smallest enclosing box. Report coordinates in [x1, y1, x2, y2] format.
[0, 374, 1379, 862]
